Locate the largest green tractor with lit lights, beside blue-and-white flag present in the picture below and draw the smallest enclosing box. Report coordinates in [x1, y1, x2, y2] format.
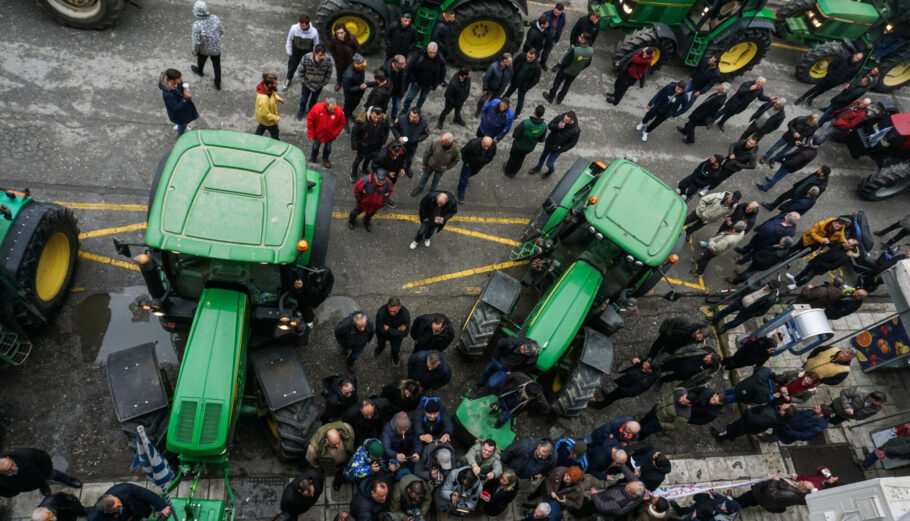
[107, 130, 335, 520]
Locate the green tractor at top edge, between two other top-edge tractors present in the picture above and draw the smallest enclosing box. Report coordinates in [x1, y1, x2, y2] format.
[588, 0, 774, 79]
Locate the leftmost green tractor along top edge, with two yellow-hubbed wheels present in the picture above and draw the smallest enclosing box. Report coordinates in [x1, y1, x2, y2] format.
[314, 0, 528, 68]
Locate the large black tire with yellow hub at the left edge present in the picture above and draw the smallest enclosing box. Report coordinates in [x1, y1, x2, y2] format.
[2, 202, 79, 328]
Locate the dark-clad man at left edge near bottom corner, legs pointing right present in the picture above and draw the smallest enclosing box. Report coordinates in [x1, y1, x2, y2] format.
[0, 448, 82, 497]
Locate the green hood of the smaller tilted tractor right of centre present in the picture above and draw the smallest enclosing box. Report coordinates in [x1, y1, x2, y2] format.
[523, 261, 603, 371]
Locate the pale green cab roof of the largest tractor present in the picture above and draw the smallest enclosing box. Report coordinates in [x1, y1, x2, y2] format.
[145, 130, 307, 264]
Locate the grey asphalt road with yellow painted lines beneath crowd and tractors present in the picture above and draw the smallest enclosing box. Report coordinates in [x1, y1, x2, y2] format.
[0, 0, 910, 478]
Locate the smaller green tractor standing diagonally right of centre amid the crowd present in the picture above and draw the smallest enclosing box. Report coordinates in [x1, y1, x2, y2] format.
[456, 159, 686, 441]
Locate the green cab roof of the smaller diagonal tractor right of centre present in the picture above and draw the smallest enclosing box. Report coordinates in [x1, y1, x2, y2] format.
[585, 159, 686, 266]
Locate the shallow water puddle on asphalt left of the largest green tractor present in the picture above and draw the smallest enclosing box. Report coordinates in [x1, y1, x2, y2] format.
[75, 286, 178, 366]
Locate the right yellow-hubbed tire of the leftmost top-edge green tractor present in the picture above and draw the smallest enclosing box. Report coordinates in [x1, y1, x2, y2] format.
[446, 0, 524, 69]
